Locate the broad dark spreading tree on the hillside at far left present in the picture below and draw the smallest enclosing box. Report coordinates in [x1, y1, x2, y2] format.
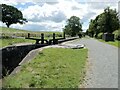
[0, 4, 27, 28]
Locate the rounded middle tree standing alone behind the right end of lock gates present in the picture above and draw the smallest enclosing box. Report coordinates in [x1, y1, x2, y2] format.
[64, 16, 82, 36]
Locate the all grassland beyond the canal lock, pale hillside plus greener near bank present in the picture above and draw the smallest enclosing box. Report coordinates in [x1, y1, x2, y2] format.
[0, 27, 62, 48]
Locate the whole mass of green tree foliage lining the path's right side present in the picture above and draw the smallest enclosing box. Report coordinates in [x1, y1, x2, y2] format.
[87, 7, 120, 37]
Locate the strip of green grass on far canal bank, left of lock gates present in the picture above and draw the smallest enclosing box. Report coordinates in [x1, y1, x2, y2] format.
[0, 38, 35, 48]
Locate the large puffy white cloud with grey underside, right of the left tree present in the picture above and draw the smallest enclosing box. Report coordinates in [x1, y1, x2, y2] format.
[22, 4, 66, 22]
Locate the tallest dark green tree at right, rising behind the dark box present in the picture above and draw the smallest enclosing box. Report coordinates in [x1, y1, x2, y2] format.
[97, 7, 119, 33]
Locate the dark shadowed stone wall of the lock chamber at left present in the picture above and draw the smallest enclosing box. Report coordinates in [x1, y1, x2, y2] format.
[0, 44, 47, 76]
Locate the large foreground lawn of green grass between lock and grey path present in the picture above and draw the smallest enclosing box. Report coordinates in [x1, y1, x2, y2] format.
[3, 48, 87, 88]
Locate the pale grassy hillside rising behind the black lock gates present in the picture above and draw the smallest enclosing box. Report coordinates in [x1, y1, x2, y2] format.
[0, 27, 62, 37]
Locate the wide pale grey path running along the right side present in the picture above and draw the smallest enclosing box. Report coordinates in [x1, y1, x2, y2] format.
[70, 39, 118, 88]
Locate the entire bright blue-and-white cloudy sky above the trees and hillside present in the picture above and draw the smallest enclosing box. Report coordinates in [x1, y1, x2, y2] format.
[0, 0, 119, 31]
